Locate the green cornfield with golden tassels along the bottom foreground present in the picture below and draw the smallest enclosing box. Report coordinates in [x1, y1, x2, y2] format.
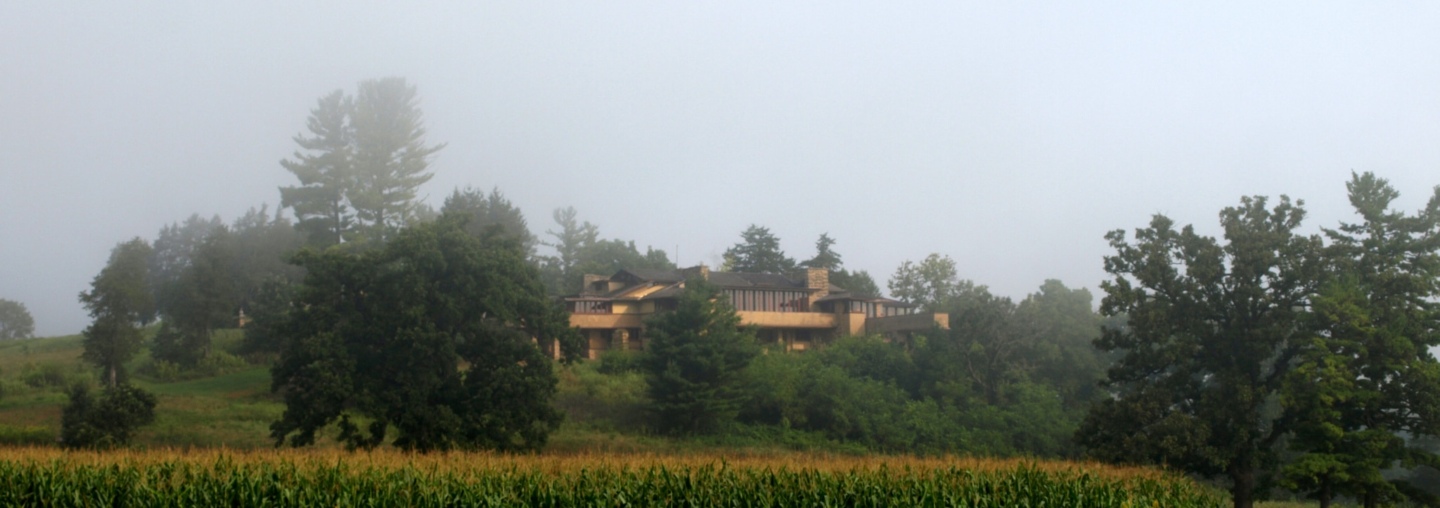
[0, 448, 1225, 507]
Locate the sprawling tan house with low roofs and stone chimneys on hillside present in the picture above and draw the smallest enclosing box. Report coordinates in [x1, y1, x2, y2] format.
[564, 265, 950, 358]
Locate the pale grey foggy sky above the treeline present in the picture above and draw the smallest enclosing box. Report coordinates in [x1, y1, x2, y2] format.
[0, 1, 1440, 335]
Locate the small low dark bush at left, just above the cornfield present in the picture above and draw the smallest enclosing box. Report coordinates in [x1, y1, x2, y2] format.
[60, 383, 156, 448]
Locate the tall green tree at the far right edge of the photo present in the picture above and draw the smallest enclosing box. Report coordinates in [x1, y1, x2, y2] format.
[1284, 173, 1440, 507]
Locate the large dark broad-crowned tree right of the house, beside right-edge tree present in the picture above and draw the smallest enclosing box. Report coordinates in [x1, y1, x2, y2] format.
[1076, 197, 1320, 508]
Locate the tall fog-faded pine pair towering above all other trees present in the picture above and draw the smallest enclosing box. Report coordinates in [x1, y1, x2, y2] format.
[281, 78, 445, 246]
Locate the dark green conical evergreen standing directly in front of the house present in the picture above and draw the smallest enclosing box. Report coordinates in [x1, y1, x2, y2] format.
[639, 278, 759, 435]
